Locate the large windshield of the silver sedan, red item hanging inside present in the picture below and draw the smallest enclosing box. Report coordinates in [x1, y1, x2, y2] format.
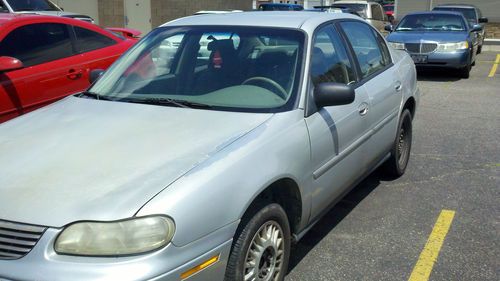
[89, 26, 305, 112]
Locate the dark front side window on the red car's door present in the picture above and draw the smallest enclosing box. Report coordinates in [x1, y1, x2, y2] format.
[0, 23, 73, 66]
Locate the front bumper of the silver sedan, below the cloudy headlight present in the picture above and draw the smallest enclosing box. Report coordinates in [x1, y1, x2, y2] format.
[0, 222, 238, 281]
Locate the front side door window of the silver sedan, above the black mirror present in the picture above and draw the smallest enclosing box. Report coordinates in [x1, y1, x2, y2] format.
[311, 26, 355, 86]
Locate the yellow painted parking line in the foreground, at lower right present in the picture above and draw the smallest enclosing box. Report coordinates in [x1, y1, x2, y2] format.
[408, 209, 456, 281]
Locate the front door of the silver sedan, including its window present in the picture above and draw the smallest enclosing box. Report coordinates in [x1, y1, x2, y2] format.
[306, 25, 369, 219]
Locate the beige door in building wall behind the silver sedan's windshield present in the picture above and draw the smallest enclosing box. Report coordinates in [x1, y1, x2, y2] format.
[125, 0, 152, 35]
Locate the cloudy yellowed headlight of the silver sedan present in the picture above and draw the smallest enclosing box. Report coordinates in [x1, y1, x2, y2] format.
[54, 216, 175, 256]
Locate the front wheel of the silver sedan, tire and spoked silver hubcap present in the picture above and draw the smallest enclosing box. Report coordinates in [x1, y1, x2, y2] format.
[224, 203, 291, 281]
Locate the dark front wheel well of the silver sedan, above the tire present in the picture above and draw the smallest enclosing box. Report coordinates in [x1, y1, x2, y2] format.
[242, 178, 302, 233]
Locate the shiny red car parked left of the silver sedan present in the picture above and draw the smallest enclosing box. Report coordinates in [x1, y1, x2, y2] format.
[0, 14, 137, 123]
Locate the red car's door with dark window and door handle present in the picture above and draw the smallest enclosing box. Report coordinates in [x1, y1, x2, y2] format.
[0, 23, 88, 121]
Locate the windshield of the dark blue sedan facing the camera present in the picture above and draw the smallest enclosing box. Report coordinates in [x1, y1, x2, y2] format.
[396, 14, 466, 31]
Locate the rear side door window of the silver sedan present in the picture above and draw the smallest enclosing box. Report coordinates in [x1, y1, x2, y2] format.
[341, 22, 388, 78]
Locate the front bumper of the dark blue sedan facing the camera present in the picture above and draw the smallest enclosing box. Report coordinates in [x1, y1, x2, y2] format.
[410, 50, 470, 68]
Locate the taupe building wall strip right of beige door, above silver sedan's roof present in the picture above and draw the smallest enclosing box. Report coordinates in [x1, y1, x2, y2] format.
[151, 0, 252, 28]
